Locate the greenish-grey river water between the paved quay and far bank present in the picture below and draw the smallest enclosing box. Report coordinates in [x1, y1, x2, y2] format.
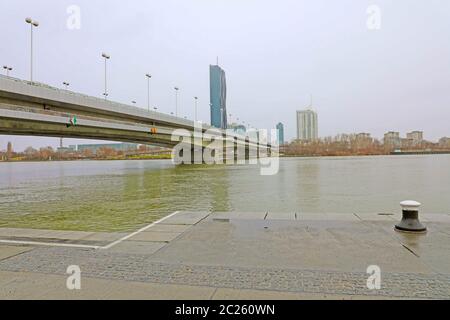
[0, 155, 450, 231]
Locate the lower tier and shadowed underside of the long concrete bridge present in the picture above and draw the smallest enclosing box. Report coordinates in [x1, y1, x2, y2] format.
[0, 109, 270, 163]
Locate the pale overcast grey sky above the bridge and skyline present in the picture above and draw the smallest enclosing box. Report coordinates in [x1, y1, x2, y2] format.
[0, 0, 450, 150]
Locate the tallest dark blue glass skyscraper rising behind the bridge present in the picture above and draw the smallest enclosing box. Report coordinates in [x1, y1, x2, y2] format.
[209, 65, 228, 129]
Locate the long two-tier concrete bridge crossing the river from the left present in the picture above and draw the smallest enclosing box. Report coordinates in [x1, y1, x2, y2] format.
[0, 76, 271, 159]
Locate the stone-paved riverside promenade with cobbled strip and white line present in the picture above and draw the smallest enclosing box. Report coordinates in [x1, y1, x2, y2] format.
[0, 212, 450, 299]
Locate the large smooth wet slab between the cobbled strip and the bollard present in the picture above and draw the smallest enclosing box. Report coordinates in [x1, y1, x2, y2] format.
[151, 220, 433, 274]
